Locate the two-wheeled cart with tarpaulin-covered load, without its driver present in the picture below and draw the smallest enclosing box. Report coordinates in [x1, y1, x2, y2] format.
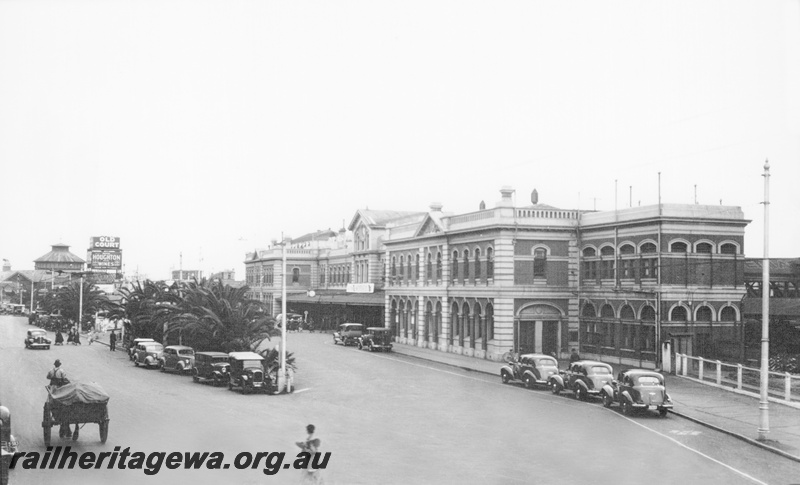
[42, 382, 109, 446]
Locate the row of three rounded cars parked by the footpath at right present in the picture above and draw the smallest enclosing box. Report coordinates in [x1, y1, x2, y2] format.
[500, 354, 673, 416]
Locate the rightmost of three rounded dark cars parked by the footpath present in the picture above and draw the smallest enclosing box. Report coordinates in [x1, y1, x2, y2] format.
[601, 369, 672, 416]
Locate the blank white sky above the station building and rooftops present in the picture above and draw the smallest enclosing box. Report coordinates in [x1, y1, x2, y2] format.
[0, 0, 800, 279]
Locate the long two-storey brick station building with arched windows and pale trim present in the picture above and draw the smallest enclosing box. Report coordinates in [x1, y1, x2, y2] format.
[245, 188, 749, 367]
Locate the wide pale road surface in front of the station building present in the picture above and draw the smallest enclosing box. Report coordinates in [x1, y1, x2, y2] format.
[0, 316, 800, 484]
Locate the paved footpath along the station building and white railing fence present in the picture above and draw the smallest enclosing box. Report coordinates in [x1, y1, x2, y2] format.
[392, 343, 800, 462]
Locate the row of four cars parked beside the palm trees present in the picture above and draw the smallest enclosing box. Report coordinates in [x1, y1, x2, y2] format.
[128, 338, 276, 393]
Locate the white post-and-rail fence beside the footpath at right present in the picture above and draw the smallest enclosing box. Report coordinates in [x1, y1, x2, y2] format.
[675, 353, 800, 403]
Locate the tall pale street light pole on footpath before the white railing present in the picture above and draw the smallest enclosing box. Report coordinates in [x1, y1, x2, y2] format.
[758, 160, 770, 441]
